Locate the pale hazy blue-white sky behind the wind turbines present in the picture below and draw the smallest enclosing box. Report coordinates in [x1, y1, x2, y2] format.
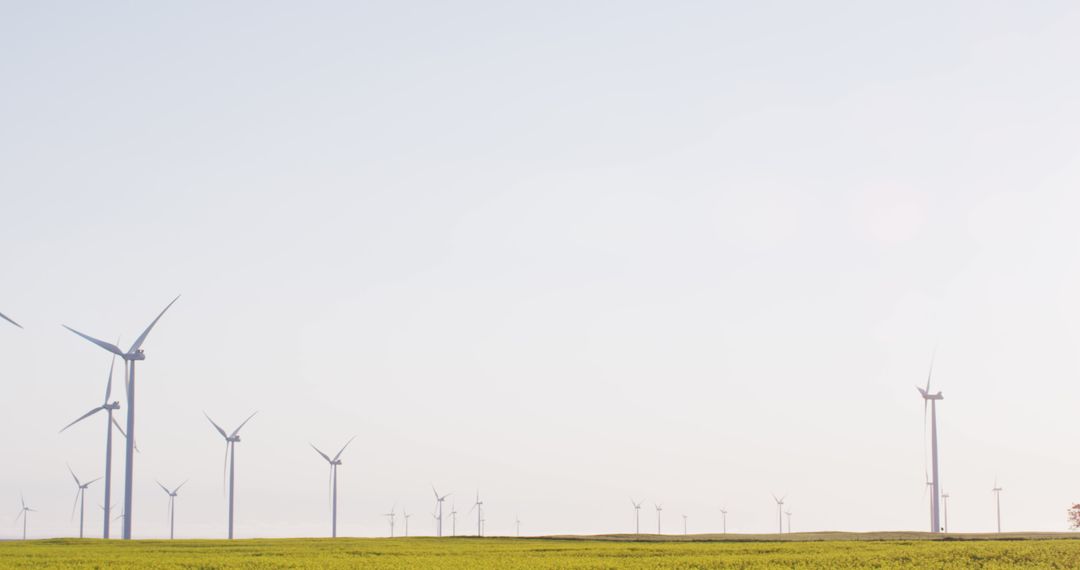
[0, 1, 1080, 538]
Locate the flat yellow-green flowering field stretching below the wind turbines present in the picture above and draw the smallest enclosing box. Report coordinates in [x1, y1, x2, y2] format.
[0, 538, 1080, 569]
